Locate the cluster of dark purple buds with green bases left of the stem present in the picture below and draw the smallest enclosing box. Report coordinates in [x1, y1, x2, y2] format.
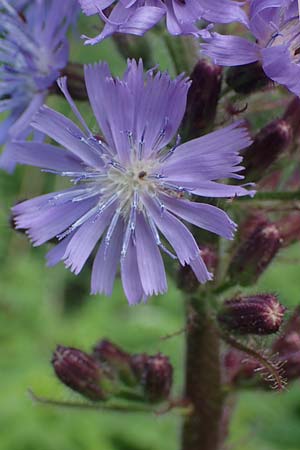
[52, 340, 173, 403]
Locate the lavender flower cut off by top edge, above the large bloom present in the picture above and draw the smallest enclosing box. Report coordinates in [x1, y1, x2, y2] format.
[79, 0, 247, 45]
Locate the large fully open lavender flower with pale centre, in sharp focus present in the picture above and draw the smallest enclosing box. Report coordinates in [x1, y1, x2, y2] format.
[13, 61, 252, 304]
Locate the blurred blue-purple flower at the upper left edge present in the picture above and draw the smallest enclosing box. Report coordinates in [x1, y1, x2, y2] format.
[0, 0, 77, 171]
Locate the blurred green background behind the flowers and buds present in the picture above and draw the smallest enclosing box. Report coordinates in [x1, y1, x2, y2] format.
[0, 16, 300, 450]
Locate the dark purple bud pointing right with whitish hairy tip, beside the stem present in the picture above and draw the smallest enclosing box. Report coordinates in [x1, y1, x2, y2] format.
[218, 294, 285, 335]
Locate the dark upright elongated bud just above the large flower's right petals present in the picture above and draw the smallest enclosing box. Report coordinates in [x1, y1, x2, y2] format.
[185, 59, 222, 138]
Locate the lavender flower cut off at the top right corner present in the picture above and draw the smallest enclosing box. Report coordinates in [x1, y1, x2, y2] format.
[202, 0, 300, 96]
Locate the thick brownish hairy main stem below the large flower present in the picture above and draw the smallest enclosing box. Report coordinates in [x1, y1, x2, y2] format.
[182, 299, 223, 450]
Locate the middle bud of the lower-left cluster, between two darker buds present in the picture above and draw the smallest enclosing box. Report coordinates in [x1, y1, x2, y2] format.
[93, 339, 137, 386]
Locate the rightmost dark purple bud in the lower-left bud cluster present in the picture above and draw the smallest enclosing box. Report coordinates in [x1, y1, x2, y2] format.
[132, 353, 173, 402]
